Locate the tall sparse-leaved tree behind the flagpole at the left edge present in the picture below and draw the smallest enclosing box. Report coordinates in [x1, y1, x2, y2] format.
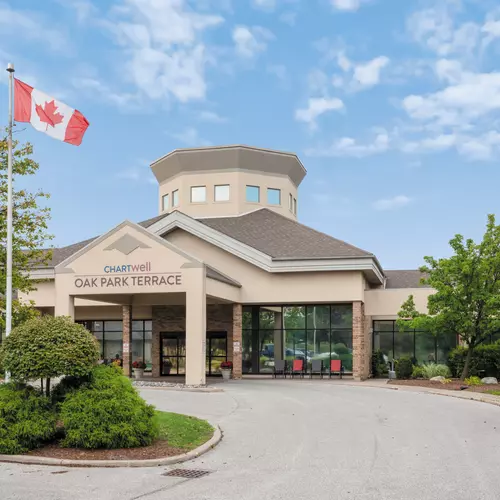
[0, 135, 52, 336]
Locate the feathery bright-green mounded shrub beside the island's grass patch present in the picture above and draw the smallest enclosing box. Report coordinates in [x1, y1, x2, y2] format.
[61, 365, 157, 449]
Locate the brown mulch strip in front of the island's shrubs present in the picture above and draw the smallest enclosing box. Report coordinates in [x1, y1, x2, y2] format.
[27, 440, 187, 460]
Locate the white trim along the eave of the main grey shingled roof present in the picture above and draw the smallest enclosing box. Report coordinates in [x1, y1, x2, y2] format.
[148, 209, 383, 284]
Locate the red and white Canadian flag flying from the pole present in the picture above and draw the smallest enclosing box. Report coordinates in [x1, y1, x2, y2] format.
[14, 78, 89, 146]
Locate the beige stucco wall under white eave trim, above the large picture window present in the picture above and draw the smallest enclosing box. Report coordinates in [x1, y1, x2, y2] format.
[167, 230, 364, 304]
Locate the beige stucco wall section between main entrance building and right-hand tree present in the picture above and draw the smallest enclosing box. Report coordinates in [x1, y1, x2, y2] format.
[365, 288, 434, 319]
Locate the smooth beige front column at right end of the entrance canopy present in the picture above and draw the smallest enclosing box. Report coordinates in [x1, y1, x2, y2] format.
[186, 272, 207, 385]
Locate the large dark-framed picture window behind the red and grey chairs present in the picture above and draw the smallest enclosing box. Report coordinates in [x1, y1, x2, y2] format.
[242, 304, 352, 373]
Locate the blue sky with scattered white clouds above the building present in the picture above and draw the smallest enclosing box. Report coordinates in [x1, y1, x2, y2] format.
[0, 0, 500, 269]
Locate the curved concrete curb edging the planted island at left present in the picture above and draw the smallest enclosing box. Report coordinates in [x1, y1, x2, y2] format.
[0, 422, 222, 468]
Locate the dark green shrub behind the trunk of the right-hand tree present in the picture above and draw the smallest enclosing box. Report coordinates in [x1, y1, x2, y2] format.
[448, 342, 500, 378]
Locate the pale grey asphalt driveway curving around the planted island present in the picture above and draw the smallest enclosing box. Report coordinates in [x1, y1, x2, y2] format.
[0, 380, 500, 500]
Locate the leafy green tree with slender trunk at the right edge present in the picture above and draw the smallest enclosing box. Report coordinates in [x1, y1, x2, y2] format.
[398, 215, 500, 380]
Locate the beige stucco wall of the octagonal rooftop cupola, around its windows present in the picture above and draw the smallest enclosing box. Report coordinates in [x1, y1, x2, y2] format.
[158, 171, 298, 219]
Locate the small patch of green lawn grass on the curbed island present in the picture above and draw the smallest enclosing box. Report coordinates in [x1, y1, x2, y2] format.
[155, 411, 214, 450]
